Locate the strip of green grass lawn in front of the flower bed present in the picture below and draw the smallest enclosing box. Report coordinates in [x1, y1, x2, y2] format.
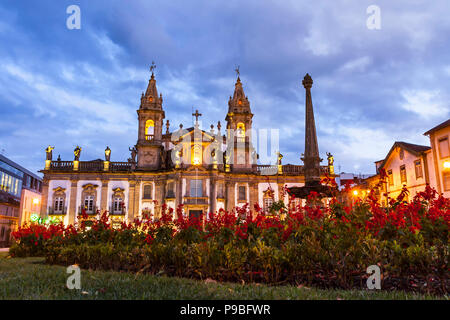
[0, 253, 448, 300]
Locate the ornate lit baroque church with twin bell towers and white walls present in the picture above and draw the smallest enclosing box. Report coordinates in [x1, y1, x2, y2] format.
[41, 70, 334, 224]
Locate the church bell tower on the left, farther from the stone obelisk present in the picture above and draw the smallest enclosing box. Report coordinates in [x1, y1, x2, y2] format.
[136, 63, 165, 170]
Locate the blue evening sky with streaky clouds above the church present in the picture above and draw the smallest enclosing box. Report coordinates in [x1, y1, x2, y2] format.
[0, 0, 450, 173]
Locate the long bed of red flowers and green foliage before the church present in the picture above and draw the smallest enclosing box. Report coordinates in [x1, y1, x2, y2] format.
[10, 186, 450, 294]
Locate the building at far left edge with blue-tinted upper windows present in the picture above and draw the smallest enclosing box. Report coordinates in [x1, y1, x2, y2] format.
[0, 155, 42, 247]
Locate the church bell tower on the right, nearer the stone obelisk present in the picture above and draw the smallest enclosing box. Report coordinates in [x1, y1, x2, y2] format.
[225, 73, 256, 171]
